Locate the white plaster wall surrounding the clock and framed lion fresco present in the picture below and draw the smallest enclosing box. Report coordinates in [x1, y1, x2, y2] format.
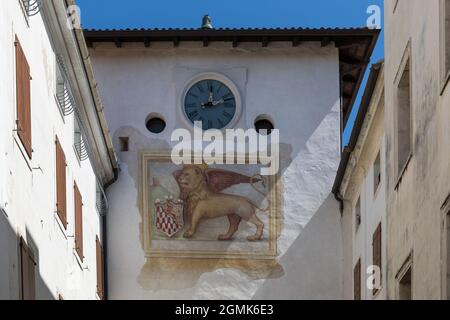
[91, 43, 342, 299]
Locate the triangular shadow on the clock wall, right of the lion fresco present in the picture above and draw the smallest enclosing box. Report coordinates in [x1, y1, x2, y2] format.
[253, 195, 342, 300]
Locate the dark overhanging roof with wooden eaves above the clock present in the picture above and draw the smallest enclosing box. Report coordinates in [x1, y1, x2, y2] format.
[84, 28, 380, 126]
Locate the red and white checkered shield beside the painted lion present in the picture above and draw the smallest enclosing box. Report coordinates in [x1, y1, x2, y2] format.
[155, 199, 184, 238]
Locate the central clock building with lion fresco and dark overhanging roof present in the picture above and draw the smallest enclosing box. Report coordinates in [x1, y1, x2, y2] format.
[85, 25, 378, 299]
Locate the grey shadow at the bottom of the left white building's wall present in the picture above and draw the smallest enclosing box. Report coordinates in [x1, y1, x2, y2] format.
[0, 210, 55, 300]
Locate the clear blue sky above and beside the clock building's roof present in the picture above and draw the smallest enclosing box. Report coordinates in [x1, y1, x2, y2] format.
[77, 0, 384, 146]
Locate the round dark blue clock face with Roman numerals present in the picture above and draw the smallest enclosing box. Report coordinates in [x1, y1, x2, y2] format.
[184, 79, 237, 130]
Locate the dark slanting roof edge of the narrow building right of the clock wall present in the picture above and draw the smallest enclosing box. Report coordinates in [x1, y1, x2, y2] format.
[333, 60, 384, 197]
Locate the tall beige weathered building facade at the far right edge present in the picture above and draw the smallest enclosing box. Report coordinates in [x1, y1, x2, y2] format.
[385, 0, 450, 299]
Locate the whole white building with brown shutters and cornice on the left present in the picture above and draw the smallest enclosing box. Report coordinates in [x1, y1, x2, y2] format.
[0, 1, 116, 299]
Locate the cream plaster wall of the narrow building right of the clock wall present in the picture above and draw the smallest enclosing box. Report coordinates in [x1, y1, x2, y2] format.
[341, 80, 388, 300]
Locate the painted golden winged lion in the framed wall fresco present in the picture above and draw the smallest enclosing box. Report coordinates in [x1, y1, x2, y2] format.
[173, 165, 270, 241]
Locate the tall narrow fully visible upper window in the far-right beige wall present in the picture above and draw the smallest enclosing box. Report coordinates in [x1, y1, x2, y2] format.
[397, 58, 412, 177]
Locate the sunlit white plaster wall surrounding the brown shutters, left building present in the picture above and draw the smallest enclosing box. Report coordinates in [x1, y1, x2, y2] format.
[0, 1, 100, 299]
